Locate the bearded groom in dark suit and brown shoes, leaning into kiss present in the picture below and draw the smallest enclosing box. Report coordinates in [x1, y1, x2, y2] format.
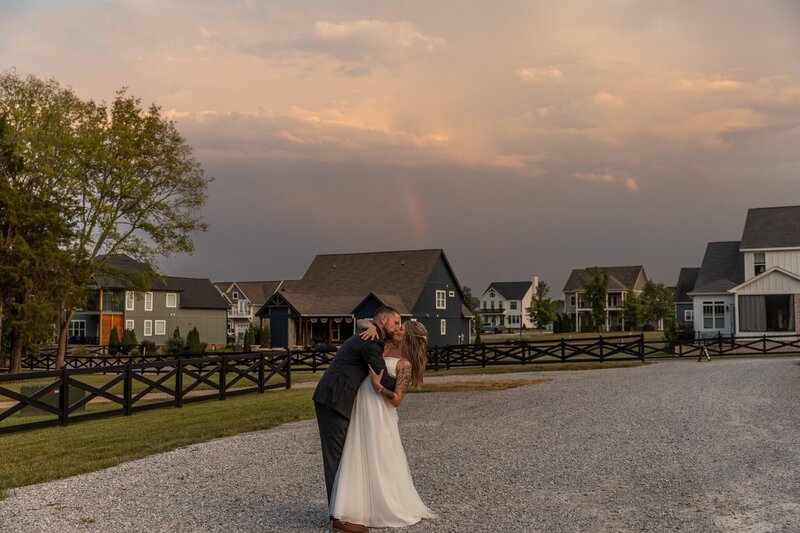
[313, 306, 400, 533]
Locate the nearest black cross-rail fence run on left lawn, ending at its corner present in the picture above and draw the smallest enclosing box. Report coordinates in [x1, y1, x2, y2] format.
[0, 352, 292, 434]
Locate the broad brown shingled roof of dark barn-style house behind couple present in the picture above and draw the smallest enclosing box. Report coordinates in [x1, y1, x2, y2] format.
[270, 249, 461, 315]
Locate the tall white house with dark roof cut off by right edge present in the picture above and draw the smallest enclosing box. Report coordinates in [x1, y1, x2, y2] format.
[730, 206, 800, 335]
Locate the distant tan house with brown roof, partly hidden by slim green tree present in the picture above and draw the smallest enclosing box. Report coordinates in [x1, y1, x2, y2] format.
[563, 265, 647, 331]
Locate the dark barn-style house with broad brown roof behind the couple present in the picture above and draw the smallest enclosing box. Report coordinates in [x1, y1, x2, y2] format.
[256, 249, 472, 348]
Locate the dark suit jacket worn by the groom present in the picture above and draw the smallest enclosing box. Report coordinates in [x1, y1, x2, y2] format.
[313, 334, 396, 420]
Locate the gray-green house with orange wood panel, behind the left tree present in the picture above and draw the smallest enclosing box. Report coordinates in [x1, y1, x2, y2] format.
[69, 255, 228, 348]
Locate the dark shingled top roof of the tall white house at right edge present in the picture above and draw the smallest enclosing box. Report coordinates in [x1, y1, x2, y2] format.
[740, 206, 800, 250]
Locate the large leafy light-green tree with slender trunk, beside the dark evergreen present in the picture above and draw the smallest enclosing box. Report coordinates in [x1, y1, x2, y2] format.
[0, 71, 209, 366]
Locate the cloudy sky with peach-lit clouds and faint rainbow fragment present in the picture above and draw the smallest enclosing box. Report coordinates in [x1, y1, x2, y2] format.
[0, 0, 800, 293]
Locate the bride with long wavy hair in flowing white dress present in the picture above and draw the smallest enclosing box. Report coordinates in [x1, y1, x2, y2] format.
[330, 321, 436, 527]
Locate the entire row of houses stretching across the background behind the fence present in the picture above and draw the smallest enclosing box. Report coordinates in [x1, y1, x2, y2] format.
[70, 206, 800, 347]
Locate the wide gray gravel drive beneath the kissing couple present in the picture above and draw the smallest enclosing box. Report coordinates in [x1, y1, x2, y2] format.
[0, 358, 800, 533]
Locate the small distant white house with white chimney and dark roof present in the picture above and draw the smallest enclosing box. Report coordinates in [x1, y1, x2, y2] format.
[479, 276, 539, 329]
